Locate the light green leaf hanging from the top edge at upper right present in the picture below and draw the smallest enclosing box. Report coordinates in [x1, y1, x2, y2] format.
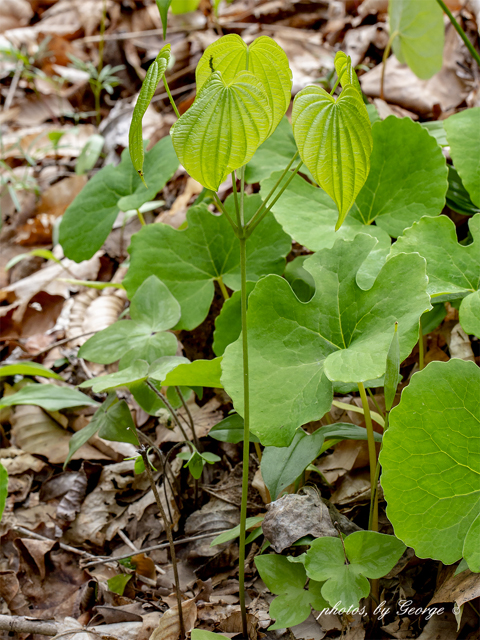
[388, 0, 445, 80]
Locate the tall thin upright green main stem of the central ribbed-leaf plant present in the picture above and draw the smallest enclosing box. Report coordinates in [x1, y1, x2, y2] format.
[238, 235, 250, 640]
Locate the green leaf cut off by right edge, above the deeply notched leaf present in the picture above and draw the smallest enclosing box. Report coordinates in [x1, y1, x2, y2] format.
[443, 107, 480, 207]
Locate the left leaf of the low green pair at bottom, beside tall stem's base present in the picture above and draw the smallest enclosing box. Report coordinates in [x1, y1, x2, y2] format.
[255, 554, 328, 630]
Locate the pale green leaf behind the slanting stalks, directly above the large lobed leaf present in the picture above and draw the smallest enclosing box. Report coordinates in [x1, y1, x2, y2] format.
[260, 173, 391, 289]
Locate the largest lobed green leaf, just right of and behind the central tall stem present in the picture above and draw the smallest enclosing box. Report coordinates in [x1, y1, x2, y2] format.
[222, 234, 430, 447]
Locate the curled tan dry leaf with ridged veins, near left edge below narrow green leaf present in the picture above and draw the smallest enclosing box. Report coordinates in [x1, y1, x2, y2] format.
[12, 405, 103, 464]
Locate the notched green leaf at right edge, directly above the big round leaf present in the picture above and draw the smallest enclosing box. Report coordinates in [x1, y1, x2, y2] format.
[391, 213, 480, 336]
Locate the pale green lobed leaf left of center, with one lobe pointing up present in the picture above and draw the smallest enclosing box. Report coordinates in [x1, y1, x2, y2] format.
[78, 276, 181, 369]
